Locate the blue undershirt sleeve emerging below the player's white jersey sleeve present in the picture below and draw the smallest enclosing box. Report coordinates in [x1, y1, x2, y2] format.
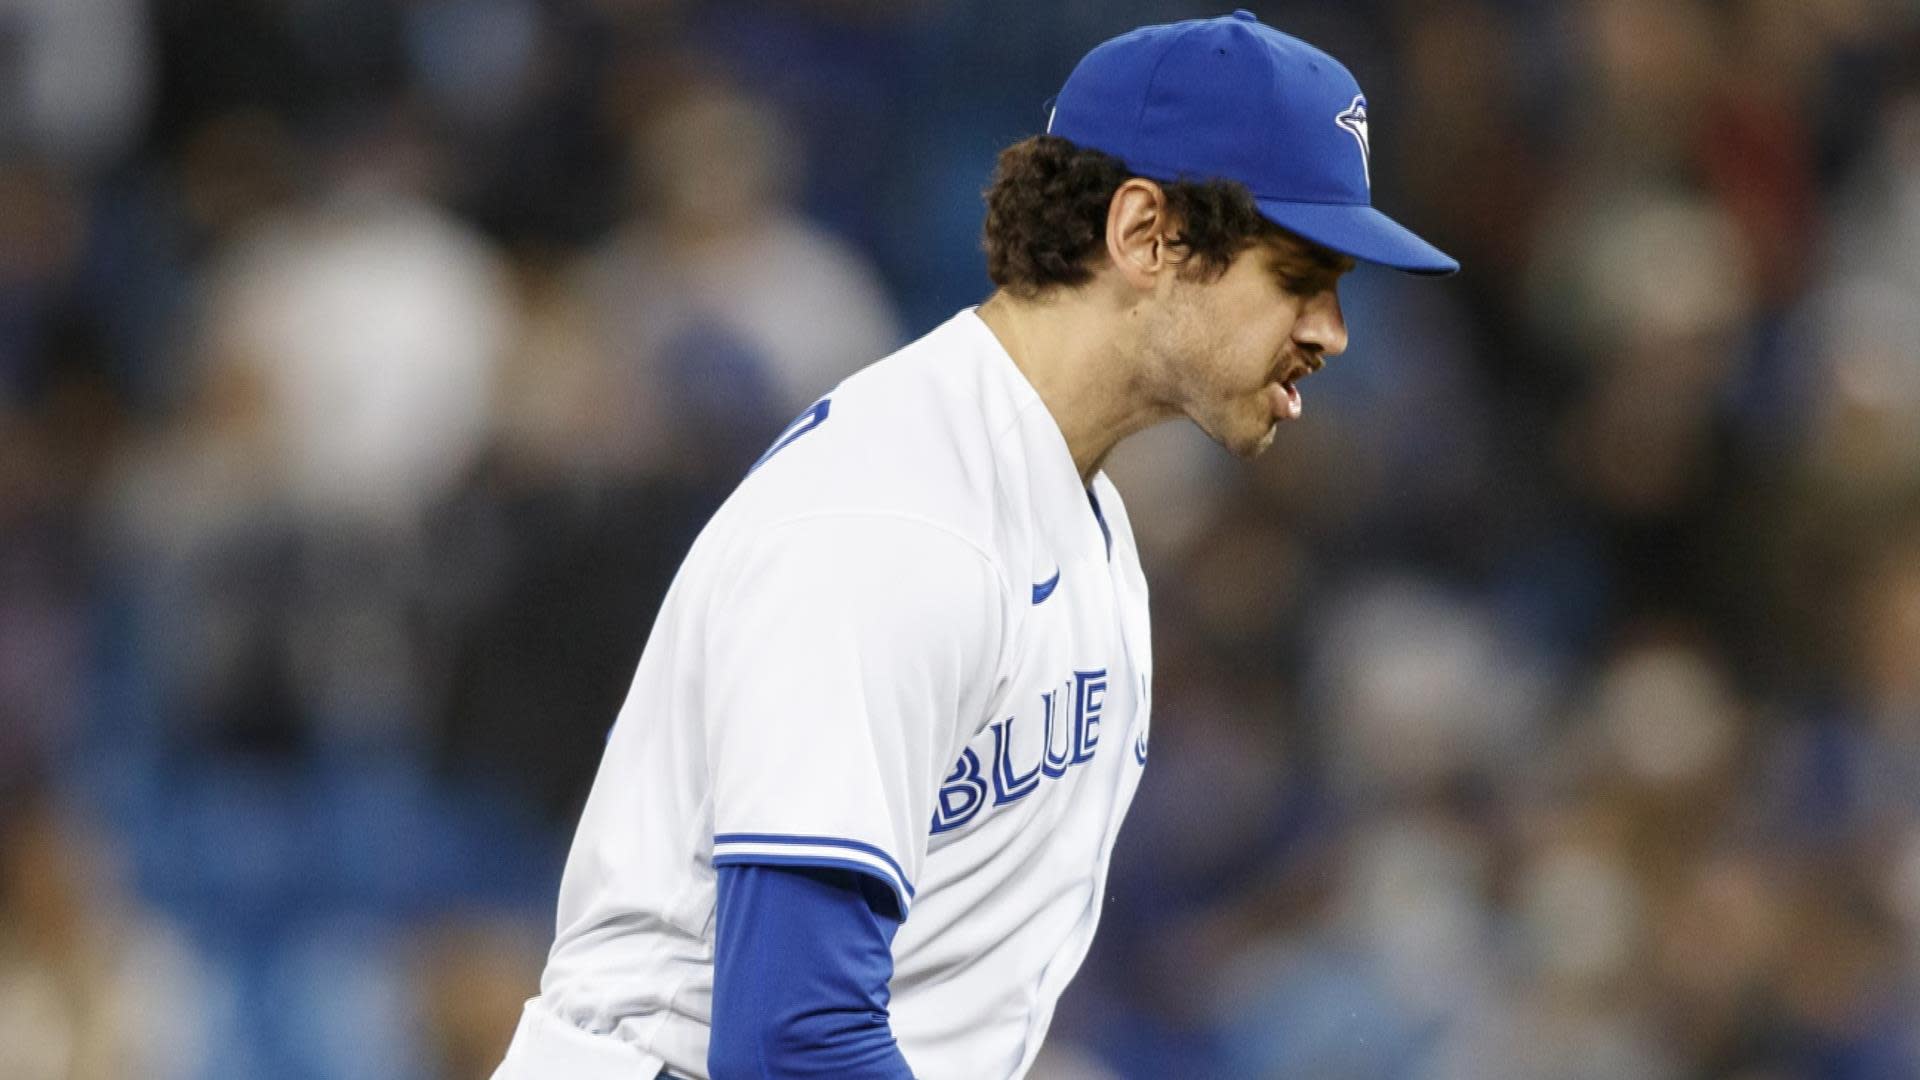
[707, 865, 914, 1080]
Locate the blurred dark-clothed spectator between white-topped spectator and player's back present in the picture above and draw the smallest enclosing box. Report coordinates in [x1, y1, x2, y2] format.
[426, 273, 721, 824]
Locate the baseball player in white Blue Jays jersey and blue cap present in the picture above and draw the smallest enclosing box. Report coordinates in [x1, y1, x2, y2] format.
[495, 12, 1457, 1080]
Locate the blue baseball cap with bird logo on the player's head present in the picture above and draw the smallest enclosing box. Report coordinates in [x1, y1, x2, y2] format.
[1046, 10, 1459, 273]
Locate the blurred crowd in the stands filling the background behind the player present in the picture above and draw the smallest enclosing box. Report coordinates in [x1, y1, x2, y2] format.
[0, 0, 1920, 1080]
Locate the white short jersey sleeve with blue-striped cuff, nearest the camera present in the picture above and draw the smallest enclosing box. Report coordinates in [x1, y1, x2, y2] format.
[705, 515, 1006, 919]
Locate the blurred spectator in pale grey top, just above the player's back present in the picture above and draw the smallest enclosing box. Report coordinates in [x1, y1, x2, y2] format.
[584, 81, 900, 472]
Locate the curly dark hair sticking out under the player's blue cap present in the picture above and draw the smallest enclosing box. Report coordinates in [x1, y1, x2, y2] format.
[983, 135, 1286, 300]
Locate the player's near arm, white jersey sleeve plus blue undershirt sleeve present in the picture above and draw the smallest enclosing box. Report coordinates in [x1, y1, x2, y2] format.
[703, 515, 1008, 1080]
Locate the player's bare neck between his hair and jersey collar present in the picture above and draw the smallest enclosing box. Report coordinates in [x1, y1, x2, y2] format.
[979, 290, 1173, 482]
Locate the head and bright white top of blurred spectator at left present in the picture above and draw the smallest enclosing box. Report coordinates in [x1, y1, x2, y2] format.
[205, 118, 516, 530]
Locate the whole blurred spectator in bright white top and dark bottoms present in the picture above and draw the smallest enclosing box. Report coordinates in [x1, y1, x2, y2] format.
[97, 111, 516, 749]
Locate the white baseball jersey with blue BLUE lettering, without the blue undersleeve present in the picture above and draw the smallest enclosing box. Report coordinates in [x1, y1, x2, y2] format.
[499, 311, 1152, 1080]
